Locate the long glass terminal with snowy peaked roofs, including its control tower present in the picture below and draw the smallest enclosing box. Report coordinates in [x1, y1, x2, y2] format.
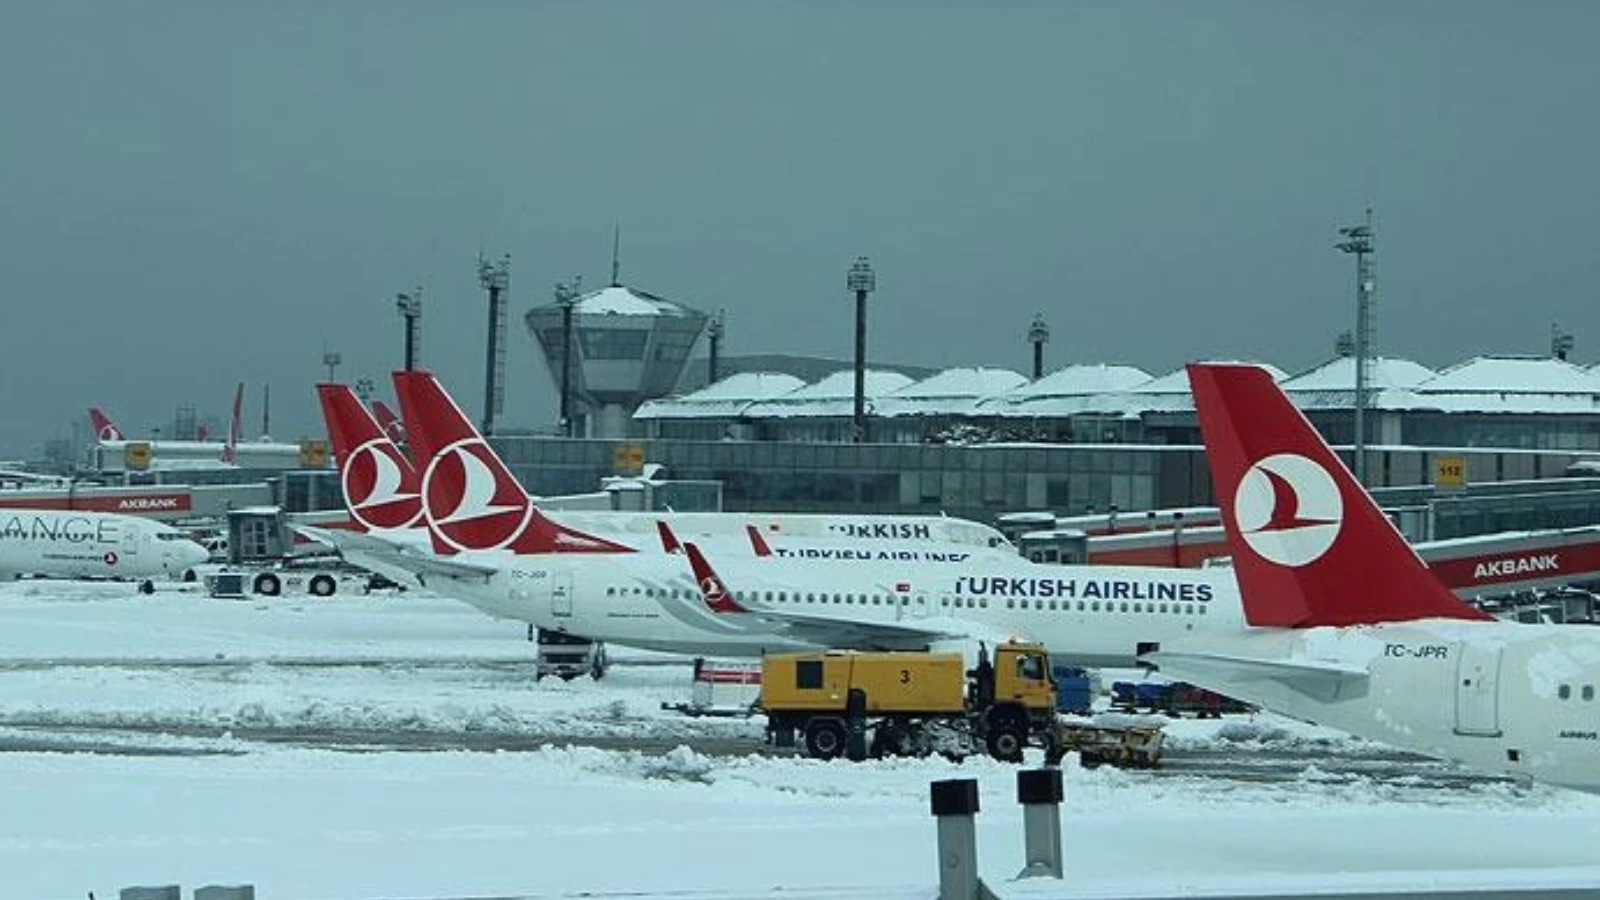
[493, 285, 1600, 538]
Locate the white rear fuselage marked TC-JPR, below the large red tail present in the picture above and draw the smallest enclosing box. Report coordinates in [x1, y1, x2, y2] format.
[1162, 620, 1600, 791]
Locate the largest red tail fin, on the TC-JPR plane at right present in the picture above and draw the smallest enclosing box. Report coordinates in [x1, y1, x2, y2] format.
[1189, 364, 1488, 628]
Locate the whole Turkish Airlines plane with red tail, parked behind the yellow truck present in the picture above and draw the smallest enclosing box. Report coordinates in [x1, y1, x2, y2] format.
[302, 372, 1243, 665]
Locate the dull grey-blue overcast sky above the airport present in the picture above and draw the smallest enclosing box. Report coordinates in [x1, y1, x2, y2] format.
[0, 0, 1600, 456]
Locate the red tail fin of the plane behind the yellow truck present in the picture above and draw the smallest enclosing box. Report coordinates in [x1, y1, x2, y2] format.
[394, 370, 634, 552]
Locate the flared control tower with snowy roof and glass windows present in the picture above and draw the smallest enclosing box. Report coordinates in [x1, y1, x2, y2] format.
[523, 283, 707, 437]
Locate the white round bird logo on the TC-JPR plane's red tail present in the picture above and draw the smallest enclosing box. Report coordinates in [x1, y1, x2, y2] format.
[1234, 453, 1344, 567]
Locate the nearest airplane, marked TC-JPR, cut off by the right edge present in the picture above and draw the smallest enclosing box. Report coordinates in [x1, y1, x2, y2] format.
[1142, 364, 1600, 791]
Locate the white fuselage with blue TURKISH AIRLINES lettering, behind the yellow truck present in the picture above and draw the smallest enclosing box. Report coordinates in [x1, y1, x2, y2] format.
[427, 551, 1243, 666]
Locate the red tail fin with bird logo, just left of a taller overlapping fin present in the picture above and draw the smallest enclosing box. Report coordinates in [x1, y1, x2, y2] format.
[317, 384, 422, 530]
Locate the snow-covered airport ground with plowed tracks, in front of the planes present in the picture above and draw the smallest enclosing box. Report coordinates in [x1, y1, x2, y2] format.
[0, 581, 1600, 900]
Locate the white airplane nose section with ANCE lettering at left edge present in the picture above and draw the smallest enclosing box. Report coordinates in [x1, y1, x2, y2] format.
[0, 508, 210, 593]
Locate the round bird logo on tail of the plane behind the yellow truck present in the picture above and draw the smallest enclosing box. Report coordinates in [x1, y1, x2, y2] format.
[422, 437, 533, 549]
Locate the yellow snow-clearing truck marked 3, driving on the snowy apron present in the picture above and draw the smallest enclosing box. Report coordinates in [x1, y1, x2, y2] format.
[760, 642, 1058, 762]
